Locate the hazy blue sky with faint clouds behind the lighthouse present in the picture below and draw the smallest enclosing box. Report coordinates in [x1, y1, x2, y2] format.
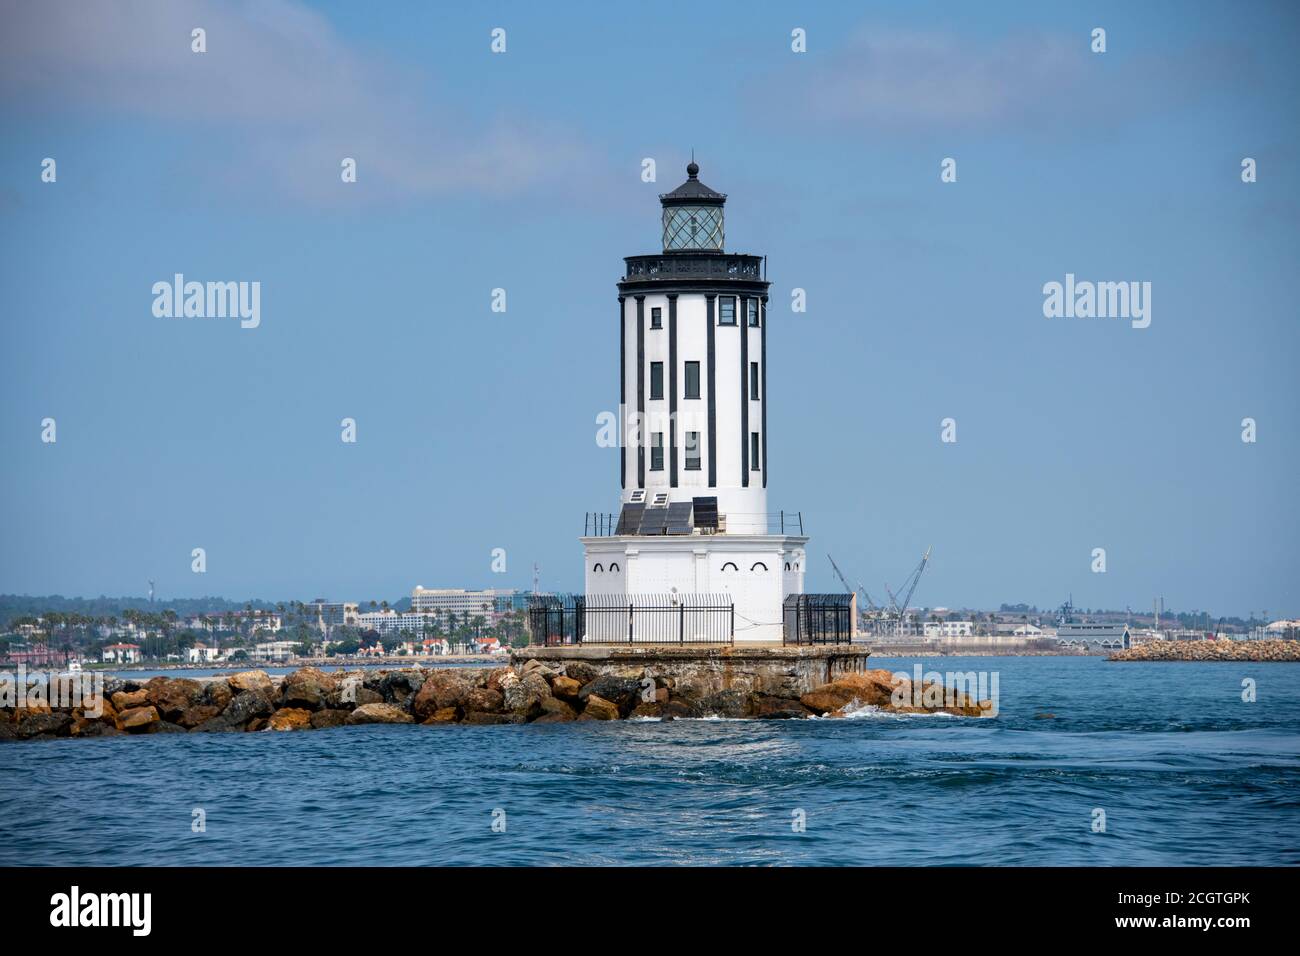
[0, 0, 1300, 618]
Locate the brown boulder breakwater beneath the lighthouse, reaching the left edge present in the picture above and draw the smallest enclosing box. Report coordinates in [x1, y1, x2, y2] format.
[0, 650, 996, 740]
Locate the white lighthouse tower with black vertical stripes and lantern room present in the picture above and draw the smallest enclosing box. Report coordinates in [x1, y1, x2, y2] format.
[582, 161, 807, 643]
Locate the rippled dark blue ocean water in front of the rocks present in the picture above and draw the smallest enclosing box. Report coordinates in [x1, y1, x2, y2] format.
[0, 657, 1300, 866]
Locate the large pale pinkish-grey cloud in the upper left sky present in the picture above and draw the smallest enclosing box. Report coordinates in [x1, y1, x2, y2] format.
[0, 0, 592, 200]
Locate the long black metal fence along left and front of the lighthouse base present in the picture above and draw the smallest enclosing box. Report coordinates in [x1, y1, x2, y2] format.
[528, 594, 736, 646]
